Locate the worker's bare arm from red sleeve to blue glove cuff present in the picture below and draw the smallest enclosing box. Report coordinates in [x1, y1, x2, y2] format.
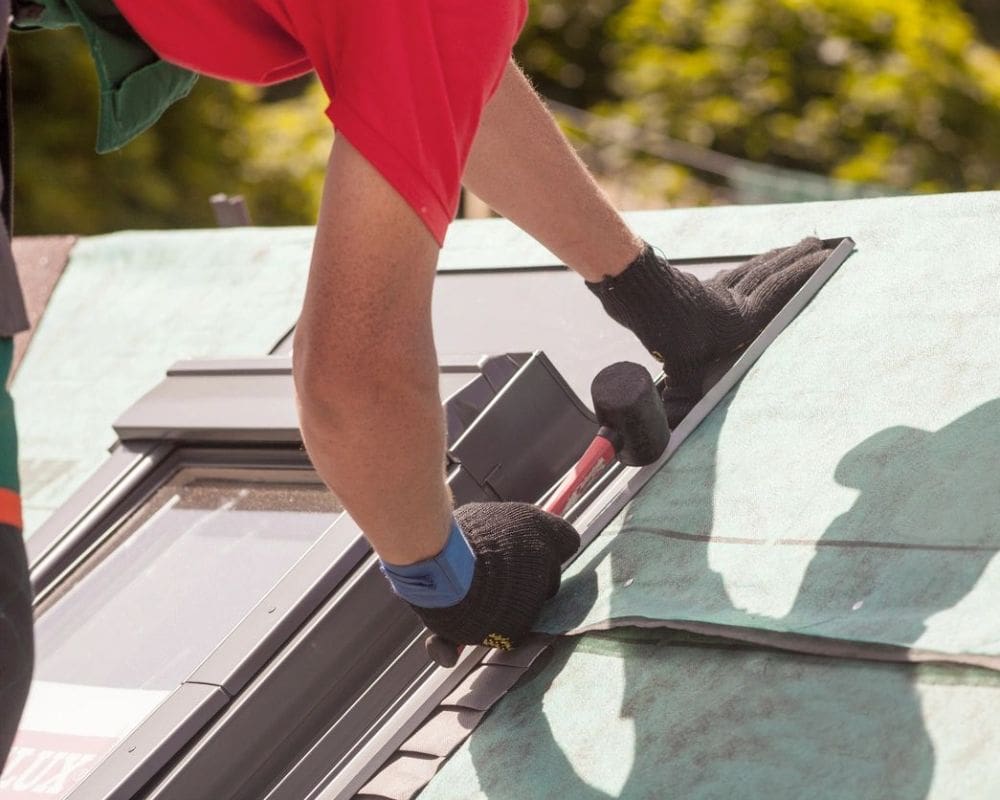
[294, 137, 451, 564]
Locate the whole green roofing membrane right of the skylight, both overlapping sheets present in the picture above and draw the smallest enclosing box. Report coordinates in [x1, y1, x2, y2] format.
[421, 193, 1000, 800]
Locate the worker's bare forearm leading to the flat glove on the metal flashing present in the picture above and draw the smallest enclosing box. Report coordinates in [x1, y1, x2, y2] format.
[465, 62, 643, 281]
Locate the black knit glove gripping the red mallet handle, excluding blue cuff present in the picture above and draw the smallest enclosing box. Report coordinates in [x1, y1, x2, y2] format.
[412, 503, 580, 650]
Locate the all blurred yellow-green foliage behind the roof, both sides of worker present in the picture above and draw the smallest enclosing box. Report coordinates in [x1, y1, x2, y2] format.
[11, 0, 1000, 233]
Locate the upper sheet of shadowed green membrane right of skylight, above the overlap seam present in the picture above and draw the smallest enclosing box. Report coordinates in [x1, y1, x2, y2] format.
[542, 193, 1000, 657]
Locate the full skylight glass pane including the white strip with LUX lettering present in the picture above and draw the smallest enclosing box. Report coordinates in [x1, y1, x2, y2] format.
[0, 468, 342, 798]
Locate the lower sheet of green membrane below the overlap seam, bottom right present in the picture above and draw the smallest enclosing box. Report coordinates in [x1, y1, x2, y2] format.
[420, 631, 1000, 800]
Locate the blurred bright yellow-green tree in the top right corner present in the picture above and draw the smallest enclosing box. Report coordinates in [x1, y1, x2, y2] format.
[604, 0, 1000, 191]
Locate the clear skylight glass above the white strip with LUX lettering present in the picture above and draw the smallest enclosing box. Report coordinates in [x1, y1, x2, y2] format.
[35, 469, 341, 690]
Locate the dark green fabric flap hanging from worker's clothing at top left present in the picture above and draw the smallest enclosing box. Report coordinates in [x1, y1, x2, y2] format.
[14, 0, 197, 153]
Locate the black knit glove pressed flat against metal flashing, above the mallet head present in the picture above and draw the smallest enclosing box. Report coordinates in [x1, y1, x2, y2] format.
[587, 238, 830, 426]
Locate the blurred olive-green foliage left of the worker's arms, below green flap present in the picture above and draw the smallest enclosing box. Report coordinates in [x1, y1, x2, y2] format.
[10, 30, 331, 234]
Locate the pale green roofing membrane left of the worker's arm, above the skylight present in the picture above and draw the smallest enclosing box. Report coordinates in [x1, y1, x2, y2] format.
[12, 228, 312, 536]
